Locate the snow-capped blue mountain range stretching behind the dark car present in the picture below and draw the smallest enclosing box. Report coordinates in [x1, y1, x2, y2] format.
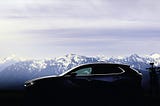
[0, 53, 160, 88]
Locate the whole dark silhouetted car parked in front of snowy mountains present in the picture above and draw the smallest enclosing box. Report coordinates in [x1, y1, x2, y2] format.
[25, 63, 142, 105]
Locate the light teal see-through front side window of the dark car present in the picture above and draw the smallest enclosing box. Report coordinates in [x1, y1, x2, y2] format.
[75, 67, 92, 76]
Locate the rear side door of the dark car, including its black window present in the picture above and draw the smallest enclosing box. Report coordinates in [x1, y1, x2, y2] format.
[89, 65, 124, 88]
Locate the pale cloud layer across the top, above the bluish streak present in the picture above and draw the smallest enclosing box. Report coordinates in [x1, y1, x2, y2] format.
[0, 0, 160, 28]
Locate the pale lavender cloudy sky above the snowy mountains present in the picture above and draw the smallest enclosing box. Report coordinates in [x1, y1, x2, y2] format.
[0, 0, 160, 58]
